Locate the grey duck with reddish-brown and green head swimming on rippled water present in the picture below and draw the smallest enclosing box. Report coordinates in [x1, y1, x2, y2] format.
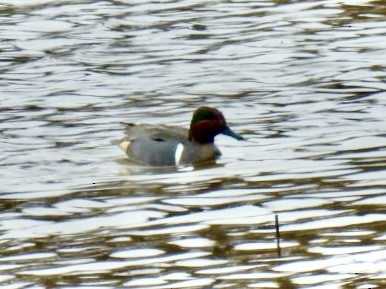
[119, 106, 245, 166]
